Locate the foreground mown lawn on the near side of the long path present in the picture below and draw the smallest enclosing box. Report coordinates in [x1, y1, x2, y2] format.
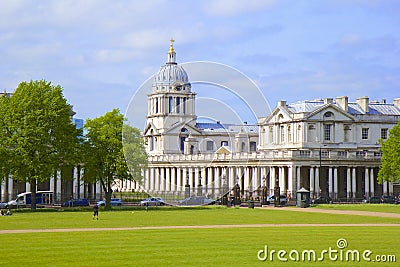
[0, 227, 400, 266]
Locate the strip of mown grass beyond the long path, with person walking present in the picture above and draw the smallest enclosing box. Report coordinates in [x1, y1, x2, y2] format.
[0, 208, 400, 229]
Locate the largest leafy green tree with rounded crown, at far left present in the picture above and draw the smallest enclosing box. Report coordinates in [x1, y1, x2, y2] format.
[1, 80, 81, 211]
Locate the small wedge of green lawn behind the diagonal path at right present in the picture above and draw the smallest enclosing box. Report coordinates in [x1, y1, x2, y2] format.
[316, 204, 400, 214]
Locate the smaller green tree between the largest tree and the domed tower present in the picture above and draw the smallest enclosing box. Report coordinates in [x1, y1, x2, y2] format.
[83, 109, 147, 209]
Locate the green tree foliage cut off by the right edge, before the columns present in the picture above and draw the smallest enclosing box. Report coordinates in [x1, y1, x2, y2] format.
[378, 121, 400, 183]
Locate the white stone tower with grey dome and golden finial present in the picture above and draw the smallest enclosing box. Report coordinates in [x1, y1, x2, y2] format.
[144, 39, 198, 155]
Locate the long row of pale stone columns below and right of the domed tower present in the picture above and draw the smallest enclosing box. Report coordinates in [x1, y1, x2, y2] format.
[144, 166, 300, 199]
